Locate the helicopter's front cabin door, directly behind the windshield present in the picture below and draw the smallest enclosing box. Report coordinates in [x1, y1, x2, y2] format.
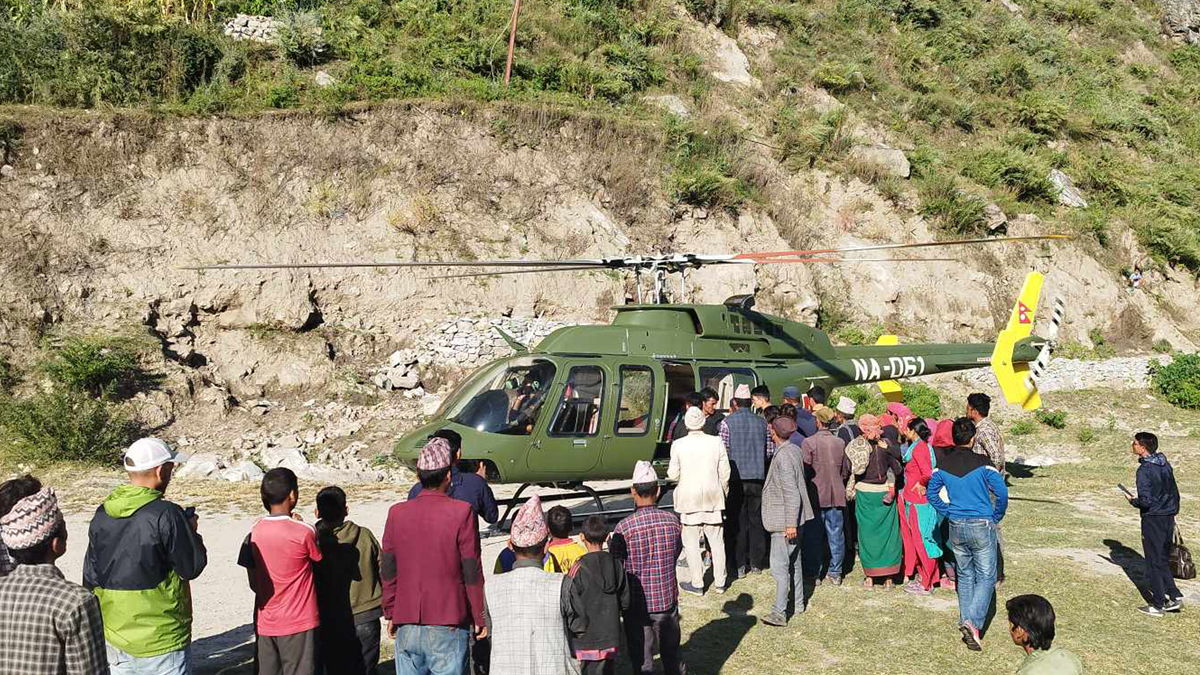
[528, 360, 612, 473]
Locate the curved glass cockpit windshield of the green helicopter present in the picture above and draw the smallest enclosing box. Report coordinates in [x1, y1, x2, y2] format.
[446, 357, 556, 436]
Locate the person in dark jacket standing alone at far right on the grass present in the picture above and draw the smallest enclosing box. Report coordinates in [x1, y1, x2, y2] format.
[1129, 431, 1183, 617]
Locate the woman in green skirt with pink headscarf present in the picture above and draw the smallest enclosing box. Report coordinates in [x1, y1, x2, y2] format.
[846, 414, 904, 589]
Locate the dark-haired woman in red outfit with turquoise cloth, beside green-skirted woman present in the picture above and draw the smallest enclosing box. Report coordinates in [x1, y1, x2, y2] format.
[898, 417, 942, 596]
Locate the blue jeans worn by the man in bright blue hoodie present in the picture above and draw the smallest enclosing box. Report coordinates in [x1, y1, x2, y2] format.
[948, 519, 996, 629]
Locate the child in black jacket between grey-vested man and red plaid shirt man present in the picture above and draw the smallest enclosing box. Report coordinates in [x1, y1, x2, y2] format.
[568, 515, 632, 675]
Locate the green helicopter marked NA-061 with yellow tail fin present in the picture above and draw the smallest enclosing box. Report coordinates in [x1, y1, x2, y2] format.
[190, 235, 1066, 504]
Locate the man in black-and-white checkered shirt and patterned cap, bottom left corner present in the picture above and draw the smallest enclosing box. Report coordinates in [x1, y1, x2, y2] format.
[0, 476, 109, 675]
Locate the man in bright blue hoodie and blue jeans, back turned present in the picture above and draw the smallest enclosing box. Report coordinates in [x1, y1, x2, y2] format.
[926, 417, 1008, 651]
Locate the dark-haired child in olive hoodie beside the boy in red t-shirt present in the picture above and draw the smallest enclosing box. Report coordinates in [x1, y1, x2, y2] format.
[316, 485, 383, 675]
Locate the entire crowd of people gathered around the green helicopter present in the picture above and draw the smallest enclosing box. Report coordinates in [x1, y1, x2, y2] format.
[0, 386, 1182, 675]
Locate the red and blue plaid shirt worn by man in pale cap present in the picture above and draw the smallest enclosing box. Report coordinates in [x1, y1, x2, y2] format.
[613, 507, 683, 614]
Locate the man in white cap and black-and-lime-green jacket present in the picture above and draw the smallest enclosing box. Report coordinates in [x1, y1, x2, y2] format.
[83, 438, 208, 675]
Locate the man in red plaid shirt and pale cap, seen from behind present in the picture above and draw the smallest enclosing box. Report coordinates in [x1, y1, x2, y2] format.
[610, 461, 683, 675]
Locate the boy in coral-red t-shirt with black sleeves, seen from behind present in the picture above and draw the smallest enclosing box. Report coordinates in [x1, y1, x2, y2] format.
[238, 467, 323, 675]
